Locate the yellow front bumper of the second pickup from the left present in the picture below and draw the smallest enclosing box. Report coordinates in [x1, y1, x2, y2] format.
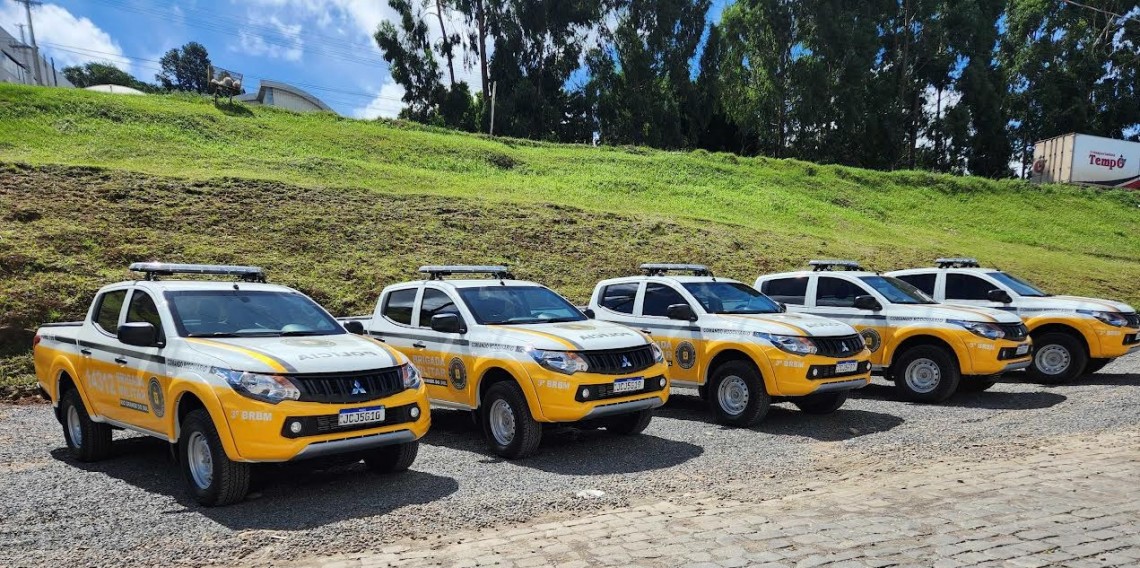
[528, 363, 670, 422]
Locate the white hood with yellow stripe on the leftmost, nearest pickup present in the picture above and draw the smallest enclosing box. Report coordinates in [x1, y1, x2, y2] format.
[187, 333, 407, 373]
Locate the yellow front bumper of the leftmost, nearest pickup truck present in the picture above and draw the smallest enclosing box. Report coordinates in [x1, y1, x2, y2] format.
[220, 384, 431, 462]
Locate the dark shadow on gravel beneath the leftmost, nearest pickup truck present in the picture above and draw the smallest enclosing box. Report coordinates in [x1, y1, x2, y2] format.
[51, 437, 459, 530]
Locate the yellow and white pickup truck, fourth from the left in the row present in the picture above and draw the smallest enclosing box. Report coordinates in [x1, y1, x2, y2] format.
[756, 260, 1031, 403]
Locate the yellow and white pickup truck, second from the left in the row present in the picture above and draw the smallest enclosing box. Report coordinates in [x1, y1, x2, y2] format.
[342, 266, 669, 459]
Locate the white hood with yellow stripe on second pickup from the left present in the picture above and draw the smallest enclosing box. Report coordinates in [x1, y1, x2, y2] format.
[488, 319, 649, 351]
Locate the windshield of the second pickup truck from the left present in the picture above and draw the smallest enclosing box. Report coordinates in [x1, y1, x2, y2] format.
[459, 285, 586, 325]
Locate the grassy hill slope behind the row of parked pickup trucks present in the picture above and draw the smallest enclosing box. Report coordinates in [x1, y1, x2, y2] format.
[0, 86, 1140, 392]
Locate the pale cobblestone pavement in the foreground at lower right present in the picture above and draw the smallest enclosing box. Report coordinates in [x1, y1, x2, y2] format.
[298, 429, 1140, 568]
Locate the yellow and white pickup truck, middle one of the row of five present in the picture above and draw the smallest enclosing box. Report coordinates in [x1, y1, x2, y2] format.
[589, 263, 871, 427]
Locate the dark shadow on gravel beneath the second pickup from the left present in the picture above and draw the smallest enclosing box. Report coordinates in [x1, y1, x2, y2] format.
[423, 409, 705, 476]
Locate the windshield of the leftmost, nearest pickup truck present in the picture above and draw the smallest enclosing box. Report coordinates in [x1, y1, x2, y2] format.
[165, 290, 347, 338]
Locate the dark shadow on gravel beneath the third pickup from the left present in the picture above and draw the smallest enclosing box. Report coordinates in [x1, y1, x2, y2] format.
[657, 392, 904, 441]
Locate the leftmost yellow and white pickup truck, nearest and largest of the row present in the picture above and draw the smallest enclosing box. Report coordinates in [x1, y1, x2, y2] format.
[34, 262, 431, 505]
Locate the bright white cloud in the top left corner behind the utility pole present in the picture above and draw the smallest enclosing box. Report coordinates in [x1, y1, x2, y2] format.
[0, 1, 131, 73]
